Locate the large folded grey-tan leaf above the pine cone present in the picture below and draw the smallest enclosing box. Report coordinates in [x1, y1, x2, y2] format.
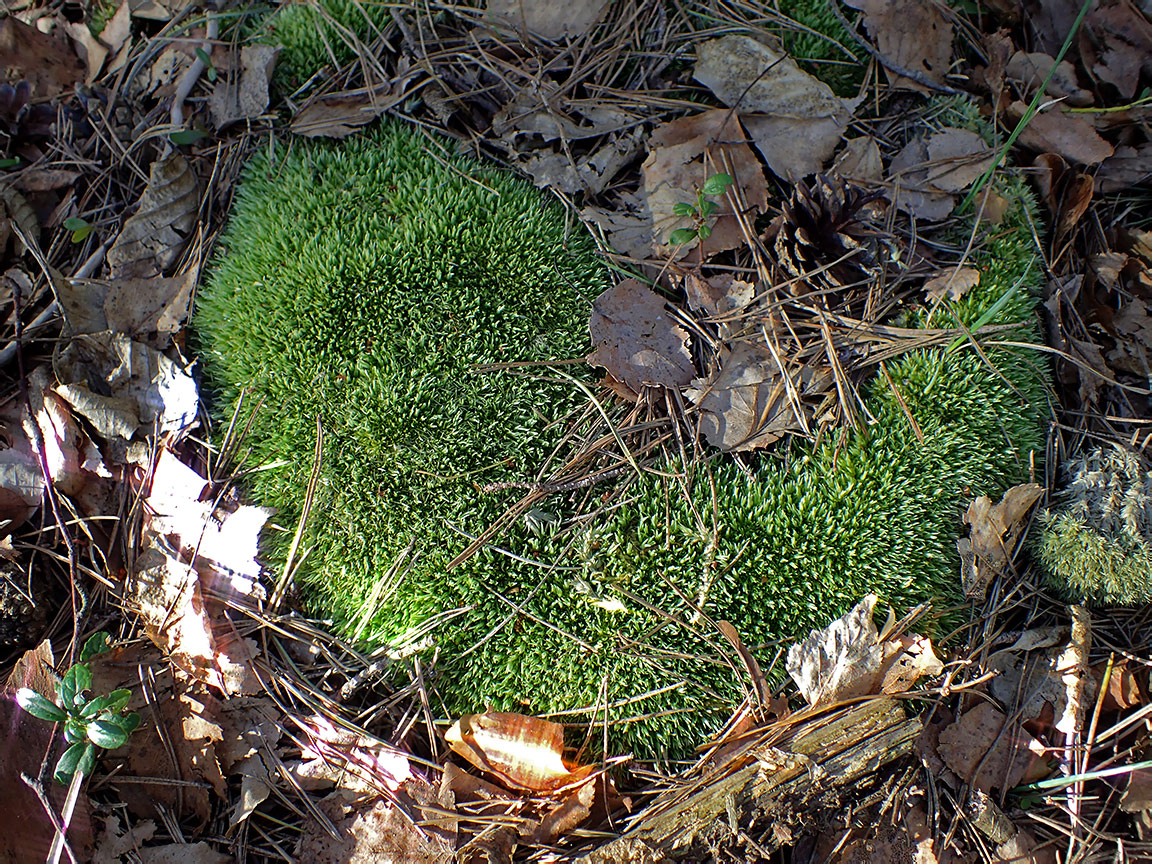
[692, 35, 855, 182]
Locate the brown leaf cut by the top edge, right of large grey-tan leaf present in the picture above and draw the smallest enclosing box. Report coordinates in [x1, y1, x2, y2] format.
[847, 0, 953, 92]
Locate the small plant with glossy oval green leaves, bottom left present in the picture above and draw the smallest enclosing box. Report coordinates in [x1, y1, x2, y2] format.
[16, 632, 141, 786]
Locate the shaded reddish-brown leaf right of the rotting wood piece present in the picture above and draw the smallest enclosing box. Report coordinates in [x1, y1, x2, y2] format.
[937, 702, 1047, 793]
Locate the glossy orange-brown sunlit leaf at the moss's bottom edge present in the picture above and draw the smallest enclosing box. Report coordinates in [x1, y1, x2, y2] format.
[444, 711, 596, 791]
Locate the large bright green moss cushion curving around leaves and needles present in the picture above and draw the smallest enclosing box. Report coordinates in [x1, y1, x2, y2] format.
[196, 116, 1046, 756]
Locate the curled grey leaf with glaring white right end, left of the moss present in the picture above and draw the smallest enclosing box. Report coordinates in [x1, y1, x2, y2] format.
[53, 331, 199, 442]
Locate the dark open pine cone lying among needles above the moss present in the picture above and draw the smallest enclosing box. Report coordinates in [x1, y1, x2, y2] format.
[775, 174, 881, 306]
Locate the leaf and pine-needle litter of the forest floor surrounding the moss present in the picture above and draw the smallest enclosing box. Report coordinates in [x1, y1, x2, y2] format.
[0, 0, 1152, 864]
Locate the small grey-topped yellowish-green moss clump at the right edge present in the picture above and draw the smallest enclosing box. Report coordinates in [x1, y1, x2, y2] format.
[1038, 446, 1152, 605]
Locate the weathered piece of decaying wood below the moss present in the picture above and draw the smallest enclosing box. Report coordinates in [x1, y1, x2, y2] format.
[581, 698, 920, 864]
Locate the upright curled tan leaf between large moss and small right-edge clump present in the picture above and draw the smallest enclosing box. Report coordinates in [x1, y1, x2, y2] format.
[960, 483, 1044, 597]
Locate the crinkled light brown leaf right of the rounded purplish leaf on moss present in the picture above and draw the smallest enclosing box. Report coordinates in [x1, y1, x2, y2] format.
[684, 341, 805, 453]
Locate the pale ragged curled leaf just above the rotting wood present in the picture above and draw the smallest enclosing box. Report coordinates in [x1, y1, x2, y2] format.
[786, 594, 943, 706]
